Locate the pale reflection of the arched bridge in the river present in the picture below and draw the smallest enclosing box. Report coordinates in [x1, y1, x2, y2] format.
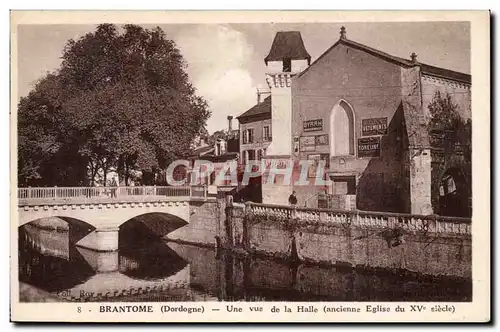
[20, 225, 190, 301]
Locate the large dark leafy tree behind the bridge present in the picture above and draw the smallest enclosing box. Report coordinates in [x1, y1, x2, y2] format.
[19, 24, 210, 185]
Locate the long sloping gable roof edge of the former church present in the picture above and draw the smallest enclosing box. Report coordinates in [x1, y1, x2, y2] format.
[298, 38, 471, 84]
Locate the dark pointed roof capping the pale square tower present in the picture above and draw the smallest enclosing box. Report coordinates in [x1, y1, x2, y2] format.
[264, 31, 311, 65]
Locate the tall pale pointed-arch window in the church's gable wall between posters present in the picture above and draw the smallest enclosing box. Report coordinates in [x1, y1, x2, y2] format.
[330, 101, 354, 156]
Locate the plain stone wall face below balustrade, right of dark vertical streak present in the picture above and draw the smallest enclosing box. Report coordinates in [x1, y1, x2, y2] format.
[294, 225, 472, 278]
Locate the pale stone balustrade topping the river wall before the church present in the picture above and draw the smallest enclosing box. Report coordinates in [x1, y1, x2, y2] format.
[246, 203, 471, 234]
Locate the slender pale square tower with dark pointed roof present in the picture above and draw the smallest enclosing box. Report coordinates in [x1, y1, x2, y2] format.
[264, 31, 311, 156]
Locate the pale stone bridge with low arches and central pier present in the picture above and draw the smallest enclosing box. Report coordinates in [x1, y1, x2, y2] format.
[17, 186, 215, 251]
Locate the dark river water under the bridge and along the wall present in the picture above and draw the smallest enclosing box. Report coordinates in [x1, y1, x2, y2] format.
[19, 219, 472, 301]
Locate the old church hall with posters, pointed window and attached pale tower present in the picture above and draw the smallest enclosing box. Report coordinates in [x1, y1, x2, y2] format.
[263, 28, 471, 215]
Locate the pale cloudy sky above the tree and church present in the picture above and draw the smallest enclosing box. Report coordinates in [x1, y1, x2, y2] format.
[18, 22, 470, 133]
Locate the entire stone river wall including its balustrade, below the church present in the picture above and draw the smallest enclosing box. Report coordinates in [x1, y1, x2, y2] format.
[228, 204, 472, 278]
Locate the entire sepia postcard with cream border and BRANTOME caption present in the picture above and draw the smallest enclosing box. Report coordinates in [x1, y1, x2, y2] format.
[10, 11, 491, 323]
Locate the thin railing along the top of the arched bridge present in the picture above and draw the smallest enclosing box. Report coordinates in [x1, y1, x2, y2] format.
[17, 186, 200, 199]
